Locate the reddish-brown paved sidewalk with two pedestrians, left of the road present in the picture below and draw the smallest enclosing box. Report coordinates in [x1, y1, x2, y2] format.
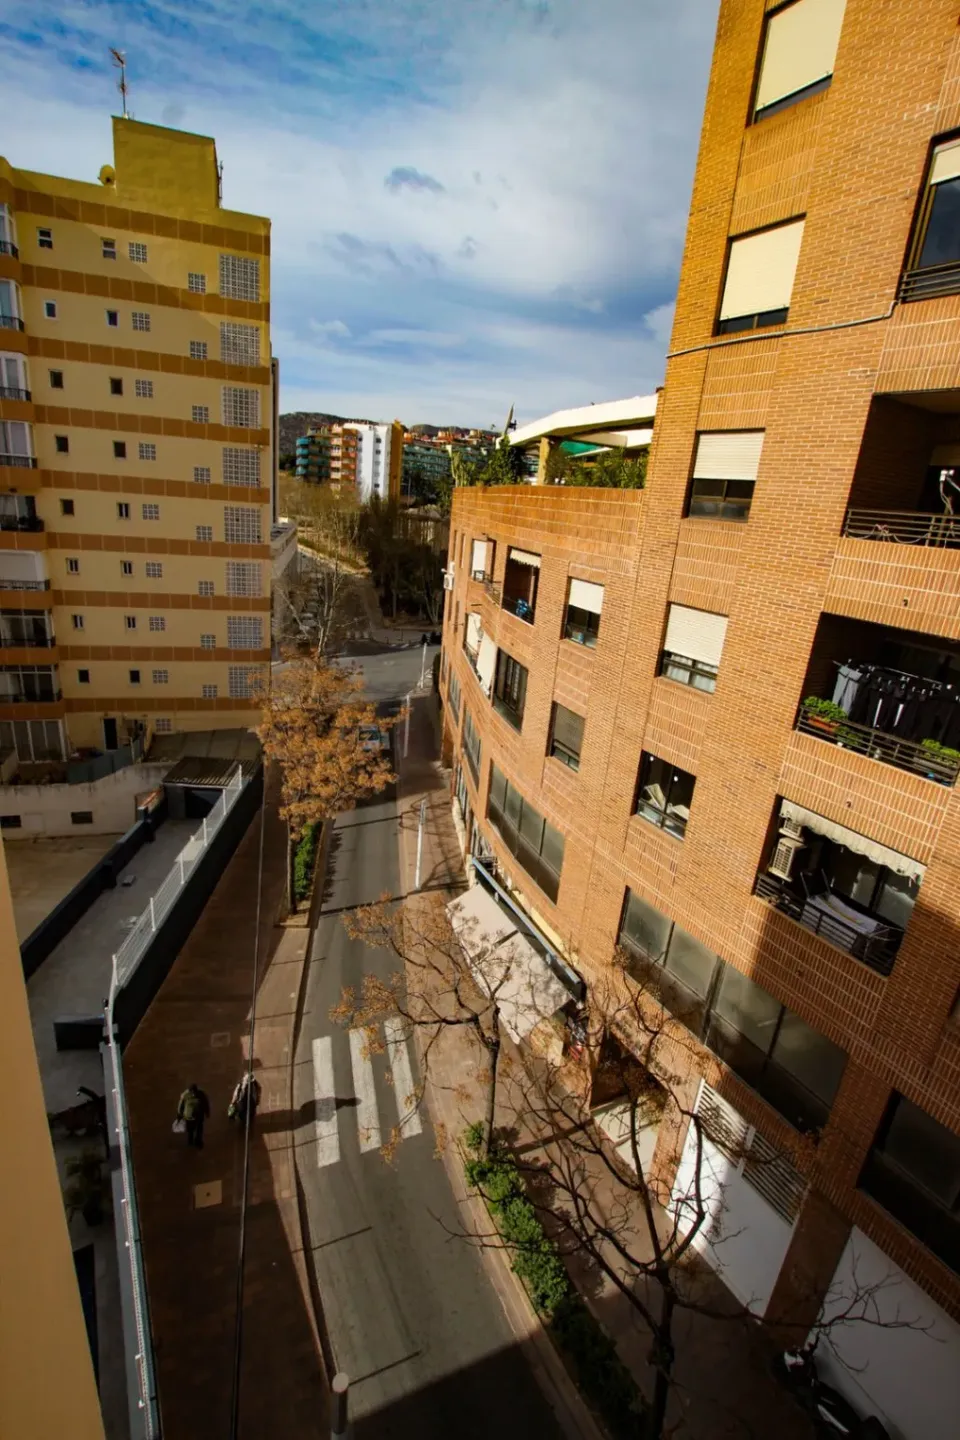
[124, 786, 328, 1440]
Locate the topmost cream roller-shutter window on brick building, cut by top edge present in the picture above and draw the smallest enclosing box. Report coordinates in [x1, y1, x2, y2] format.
[754, 0, 846, 117]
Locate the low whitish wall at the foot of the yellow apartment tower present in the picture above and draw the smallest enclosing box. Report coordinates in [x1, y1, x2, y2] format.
[0, 760, 173, 845]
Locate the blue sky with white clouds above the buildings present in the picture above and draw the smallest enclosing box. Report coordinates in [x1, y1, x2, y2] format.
[0, 0, 717, 425]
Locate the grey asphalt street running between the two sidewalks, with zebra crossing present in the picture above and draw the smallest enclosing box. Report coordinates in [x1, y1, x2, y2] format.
[295, 648, 561, 1440]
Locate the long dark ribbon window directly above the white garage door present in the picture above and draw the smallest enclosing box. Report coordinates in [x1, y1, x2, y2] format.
[619, 890, 846, 1130]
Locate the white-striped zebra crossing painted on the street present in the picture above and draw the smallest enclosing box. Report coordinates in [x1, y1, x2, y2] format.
[312, 1017, 423, 1169]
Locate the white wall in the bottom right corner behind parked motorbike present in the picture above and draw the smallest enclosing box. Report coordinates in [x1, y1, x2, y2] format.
[818, 1230, 960, 1440]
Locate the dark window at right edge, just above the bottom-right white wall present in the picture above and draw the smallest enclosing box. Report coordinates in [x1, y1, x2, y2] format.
[858, 1092, 960, 1273]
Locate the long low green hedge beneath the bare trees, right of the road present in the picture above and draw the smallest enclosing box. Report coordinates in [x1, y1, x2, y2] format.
[463, 1125, 645, 1440]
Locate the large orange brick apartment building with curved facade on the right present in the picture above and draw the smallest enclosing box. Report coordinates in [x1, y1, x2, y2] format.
[440, 0, 960, 1440]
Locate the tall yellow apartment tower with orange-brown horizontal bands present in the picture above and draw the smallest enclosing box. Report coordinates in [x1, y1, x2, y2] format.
[0, 118, 275, 760]
